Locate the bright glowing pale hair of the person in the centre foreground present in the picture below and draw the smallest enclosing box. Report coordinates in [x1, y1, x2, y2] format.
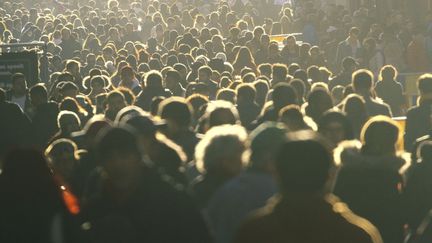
[195, 125, 249, 173]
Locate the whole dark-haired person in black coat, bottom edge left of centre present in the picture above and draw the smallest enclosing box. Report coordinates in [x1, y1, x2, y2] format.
[83, 128, 210, 243]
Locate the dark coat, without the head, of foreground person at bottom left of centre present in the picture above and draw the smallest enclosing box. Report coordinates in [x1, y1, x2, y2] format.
[83, 168, 211, 243]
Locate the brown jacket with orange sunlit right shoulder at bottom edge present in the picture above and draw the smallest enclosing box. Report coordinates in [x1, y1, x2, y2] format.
[234, 195, 382, 243]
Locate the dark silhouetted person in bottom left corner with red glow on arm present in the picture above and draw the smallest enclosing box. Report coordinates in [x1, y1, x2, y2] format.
[0, 149, 80, 243]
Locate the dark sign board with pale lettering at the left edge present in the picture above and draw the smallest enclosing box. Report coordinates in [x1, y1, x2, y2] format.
[0, 51, 39, 89]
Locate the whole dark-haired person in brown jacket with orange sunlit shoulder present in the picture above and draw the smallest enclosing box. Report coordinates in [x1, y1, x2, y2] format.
[234, 132, 382, 243]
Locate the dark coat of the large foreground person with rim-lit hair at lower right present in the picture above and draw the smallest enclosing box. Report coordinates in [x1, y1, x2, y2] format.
[334, 143, 406, 243]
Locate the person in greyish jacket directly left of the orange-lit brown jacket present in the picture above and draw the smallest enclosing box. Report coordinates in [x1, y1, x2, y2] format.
[205, 122, 286, 243]
